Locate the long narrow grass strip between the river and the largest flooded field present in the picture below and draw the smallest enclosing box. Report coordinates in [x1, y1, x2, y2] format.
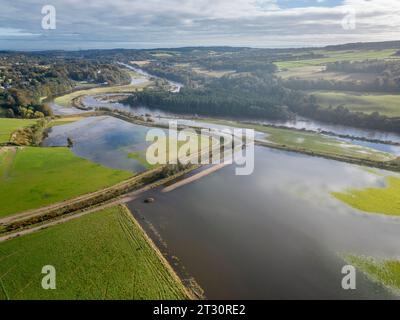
[197, 119, 395, 161]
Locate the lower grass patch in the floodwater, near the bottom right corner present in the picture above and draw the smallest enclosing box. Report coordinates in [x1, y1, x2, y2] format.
[345, 255, 400, 292]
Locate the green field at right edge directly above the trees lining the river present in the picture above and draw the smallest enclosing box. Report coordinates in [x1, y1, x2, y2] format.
[309, 91, 400, 117]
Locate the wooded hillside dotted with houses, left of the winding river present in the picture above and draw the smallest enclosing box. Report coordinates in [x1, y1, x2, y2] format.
[0, 53, 130, 118]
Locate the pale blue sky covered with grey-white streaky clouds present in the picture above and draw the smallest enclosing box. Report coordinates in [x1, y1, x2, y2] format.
[0, 0, 400, 50]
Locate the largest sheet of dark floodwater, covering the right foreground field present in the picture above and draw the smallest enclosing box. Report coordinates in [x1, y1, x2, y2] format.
[129, 147, 400, 299]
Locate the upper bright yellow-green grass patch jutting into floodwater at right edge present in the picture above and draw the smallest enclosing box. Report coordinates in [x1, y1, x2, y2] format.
[332, 177, 400, 216]
